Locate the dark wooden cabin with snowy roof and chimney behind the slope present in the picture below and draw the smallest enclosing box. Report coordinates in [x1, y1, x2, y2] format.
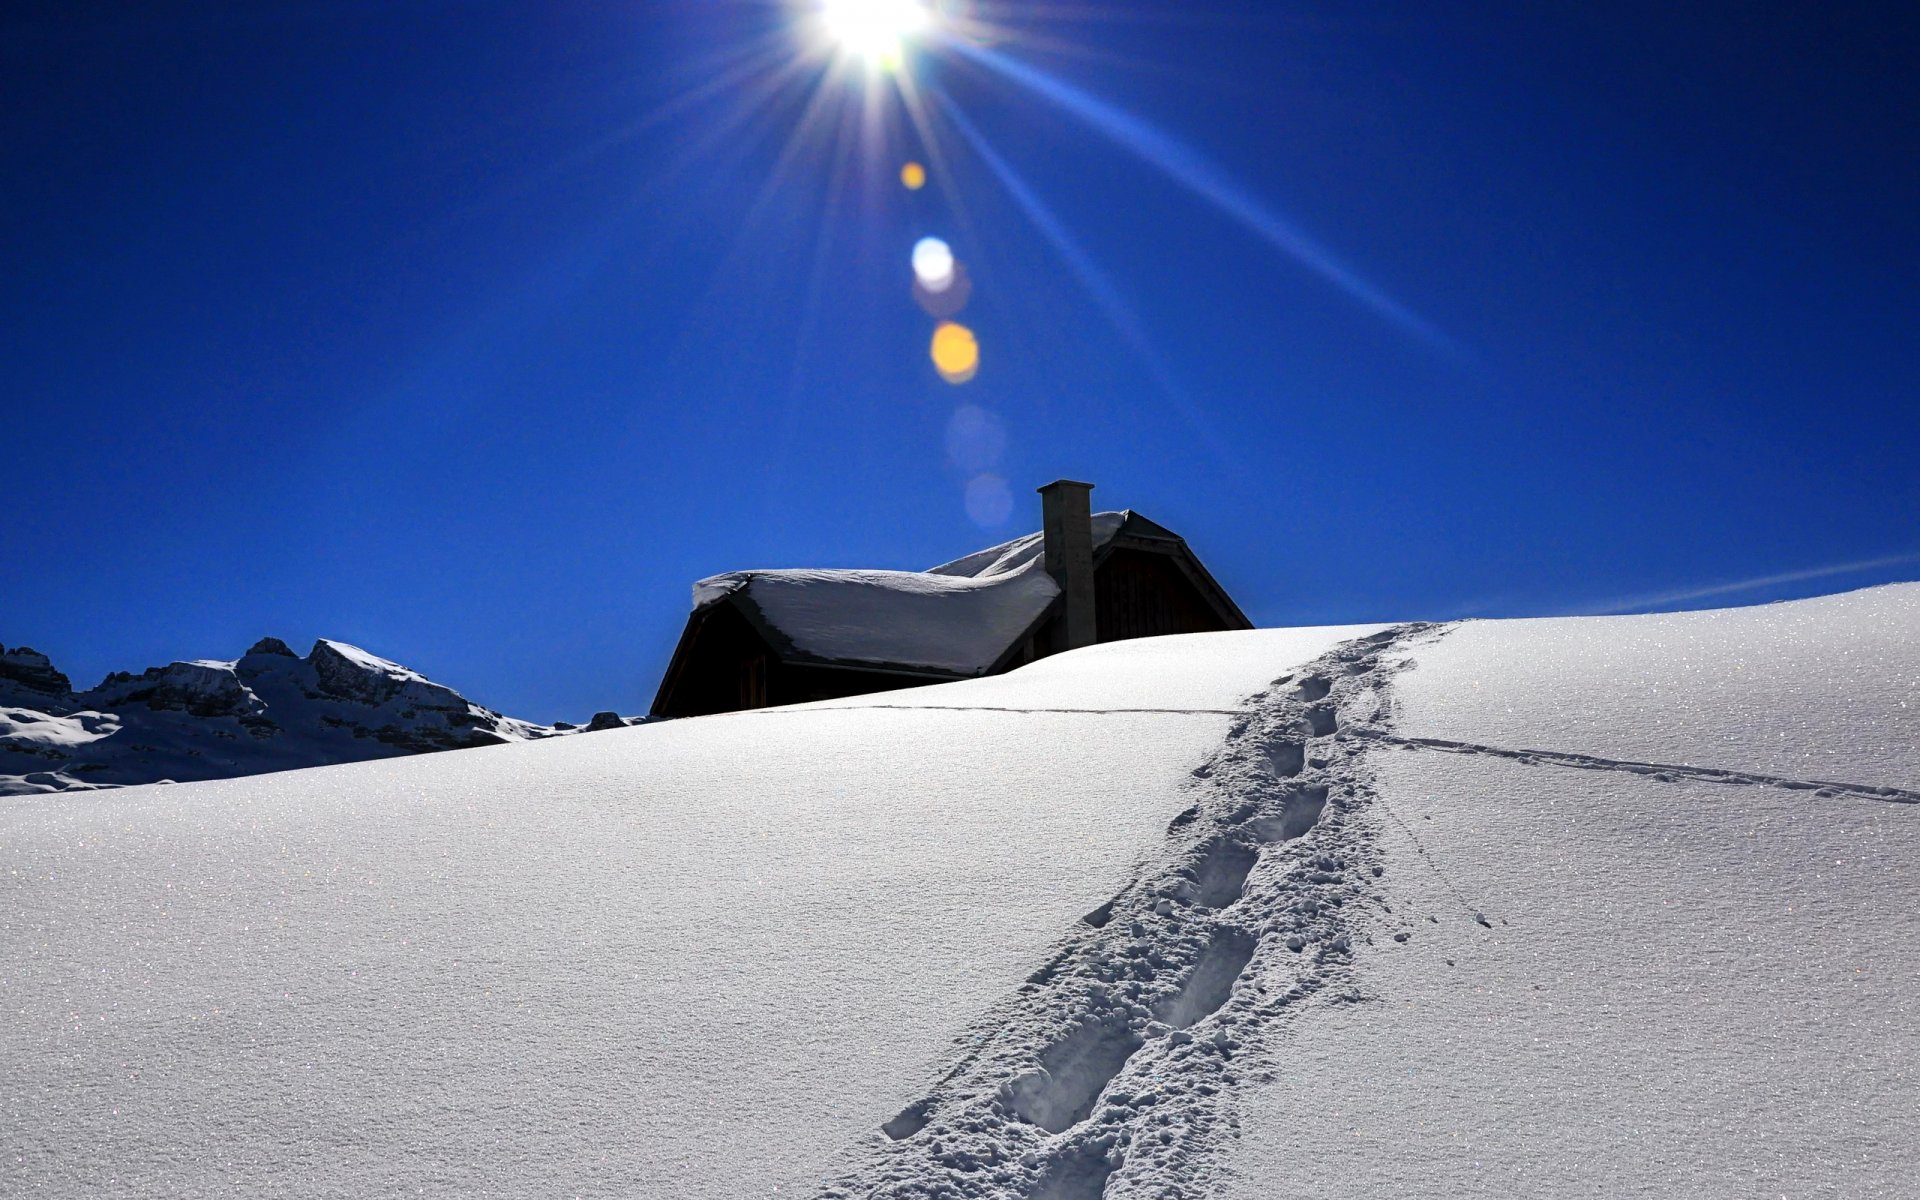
[653, 480, 1252, 716]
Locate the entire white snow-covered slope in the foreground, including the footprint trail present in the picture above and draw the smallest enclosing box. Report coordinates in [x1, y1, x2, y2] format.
[0, 586, 1920, 1200]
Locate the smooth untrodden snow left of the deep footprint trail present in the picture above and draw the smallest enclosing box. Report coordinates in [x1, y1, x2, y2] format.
[0, 630, 1356, 1200]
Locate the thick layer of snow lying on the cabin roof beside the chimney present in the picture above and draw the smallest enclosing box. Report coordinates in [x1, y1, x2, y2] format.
[693, 513, 1131, 676]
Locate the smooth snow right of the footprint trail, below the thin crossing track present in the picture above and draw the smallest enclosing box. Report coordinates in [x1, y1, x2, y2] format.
[1219, 752, 1920, 1200]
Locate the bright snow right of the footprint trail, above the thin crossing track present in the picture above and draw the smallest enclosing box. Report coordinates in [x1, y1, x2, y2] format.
[1398, 584, 1920, 789]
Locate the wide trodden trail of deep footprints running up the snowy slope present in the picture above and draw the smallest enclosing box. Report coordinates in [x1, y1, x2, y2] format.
[816, 624, 1443, 1200]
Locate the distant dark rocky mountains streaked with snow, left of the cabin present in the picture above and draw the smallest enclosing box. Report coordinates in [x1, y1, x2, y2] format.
[0, 637, 629, 797]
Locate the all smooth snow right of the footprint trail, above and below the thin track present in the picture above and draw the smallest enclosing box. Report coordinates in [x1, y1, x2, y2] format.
[1219, 584, 1920, 1200]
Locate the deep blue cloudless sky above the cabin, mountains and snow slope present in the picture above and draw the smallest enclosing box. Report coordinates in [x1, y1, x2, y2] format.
[0, 0, 1920, 720]
